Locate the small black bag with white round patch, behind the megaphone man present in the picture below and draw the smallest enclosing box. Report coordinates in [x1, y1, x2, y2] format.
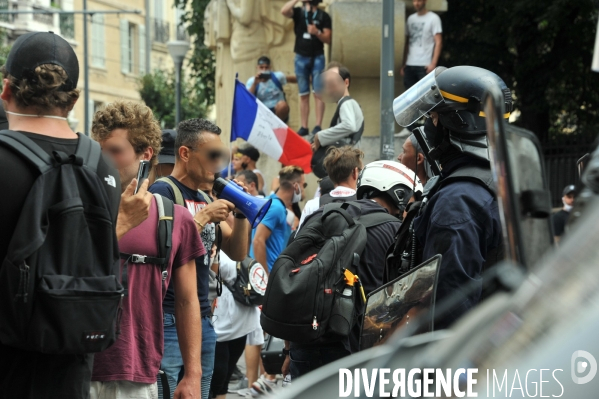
[226, 256, 268, 306]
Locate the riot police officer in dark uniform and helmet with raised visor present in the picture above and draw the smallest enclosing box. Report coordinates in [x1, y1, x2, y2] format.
[388, 66, 512, 329]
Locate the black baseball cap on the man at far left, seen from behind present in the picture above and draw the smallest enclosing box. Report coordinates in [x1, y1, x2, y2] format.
[5, 32, 79, 91]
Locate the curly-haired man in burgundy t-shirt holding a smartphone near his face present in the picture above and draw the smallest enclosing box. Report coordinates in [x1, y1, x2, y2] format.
[91, 101, 206, 399]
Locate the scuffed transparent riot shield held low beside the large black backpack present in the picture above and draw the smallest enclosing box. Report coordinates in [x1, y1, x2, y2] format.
[360, 255, 441, 350]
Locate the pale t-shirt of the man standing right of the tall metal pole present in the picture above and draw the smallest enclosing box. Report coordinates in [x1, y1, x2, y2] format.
[406, 11, 443, 66]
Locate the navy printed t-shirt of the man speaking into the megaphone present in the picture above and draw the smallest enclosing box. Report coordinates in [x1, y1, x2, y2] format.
[149, 176, 216, 316]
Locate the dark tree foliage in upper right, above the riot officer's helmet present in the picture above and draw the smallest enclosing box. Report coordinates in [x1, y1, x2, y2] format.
[439, 0, 599, 143]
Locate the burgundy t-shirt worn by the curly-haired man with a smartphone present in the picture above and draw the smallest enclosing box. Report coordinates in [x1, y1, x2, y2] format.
[92, 200, 206, 384]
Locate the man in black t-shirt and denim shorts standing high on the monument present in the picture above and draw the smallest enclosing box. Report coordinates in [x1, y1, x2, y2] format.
[281, 0, 332, 136]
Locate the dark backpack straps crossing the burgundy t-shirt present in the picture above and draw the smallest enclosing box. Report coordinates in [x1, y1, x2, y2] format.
[119, 194, 175, 295]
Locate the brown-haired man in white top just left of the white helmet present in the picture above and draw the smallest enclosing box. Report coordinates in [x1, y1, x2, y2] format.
[296, 146, 364, 231]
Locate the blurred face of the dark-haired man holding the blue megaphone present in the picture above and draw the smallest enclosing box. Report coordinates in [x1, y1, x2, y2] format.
[179, 132, 225, 184]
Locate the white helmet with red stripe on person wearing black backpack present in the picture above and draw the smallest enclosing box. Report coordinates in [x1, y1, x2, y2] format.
[357, 161, 423, 213]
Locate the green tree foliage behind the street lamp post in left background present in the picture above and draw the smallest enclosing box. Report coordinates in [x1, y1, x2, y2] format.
[139, 70, 207, 129]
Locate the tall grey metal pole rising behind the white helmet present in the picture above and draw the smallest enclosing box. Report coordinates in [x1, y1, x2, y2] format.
[380, 0, 395, 160]
